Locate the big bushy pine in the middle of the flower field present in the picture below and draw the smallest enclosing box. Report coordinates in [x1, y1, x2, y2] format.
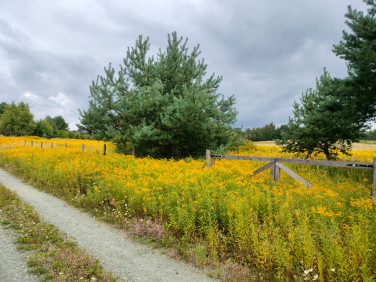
[79, 33, 237, 158]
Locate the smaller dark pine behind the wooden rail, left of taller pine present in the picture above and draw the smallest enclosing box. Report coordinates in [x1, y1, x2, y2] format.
[277, 70, 364, 160]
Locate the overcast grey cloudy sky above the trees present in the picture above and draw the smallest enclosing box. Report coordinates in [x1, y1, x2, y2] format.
[0, 0, 366, 129]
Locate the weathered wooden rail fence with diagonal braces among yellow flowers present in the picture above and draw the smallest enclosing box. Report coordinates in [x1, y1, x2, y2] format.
[206, 150, 376, 199]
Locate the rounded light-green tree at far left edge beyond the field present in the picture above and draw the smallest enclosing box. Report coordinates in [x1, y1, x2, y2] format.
[0, 102, 35, 136]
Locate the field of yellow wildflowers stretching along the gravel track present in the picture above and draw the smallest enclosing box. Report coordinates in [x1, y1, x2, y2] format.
[0, 137, 376, 281]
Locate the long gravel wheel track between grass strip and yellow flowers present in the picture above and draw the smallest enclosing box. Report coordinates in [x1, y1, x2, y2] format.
[0, 169, 214, 281]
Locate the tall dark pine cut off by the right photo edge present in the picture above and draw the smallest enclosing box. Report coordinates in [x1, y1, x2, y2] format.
[333, 0, 376, 122]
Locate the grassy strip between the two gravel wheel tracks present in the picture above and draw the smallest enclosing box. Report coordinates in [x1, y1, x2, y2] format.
[0, 185, 116, 281]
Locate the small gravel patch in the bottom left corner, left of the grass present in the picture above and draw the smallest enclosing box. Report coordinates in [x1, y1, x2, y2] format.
[0, 221, 37, 282]
